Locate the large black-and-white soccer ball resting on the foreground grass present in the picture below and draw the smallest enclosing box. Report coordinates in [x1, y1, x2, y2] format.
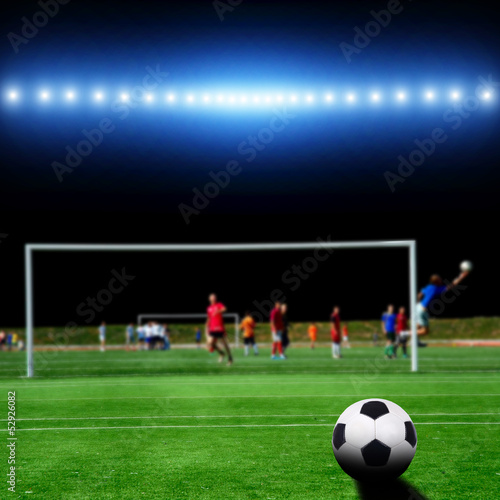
[332, 399, 417, 482]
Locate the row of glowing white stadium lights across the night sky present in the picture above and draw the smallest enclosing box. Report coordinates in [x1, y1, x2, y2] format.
[3, 90, 492, 105]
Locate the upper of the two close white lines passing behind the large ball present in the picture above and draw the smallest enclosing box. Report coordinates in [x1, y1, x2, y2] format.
[4, 413, 500, 422]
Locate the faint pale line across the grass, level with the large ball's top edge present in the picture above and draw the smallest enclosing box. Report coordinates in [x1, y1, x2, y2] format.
[18, 394, 500, 402]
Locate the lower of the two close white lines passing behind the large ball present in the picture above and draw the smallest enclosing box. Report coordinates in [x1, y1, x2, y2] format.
[0, 422, 500, 433]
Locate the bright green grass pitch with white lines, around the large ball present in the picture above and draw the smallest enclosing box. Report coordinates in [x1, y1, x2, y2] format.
[0, 348, 500, 500]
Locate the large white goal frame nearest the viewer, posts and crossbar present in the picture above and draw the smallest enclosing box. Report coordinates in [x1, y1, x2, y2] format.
[24, 240, 418, 377]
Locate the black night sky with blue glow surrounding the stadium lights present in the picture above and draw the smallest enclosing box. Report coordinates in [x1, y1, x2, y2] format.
[0, 0, 500, 326]
